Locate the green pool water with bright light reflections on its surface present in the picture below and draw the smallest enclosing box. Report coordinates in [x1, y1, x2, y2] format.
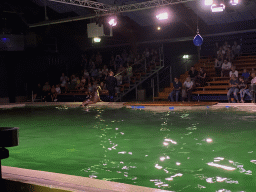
[0, 107, 256, 192]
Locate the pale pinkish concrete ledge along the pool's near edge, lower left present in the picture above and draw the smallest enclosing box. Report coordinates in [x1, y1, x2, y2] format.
[2, 166, 170, 192]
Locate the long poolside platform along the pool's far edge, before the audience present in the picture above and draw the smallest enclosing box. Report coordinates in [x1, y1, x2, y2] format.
[0, 101, 256, 113]
